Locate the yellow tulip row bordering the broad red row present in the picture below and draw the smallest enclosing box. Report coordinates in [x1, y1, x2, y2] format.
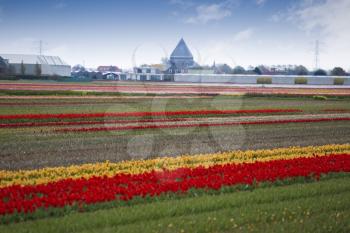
[0, 144, 350, 187]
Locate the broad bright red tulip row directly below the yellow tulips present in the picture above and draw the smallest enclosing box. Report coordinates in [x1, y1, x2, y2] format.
[0, 154, 350, 215]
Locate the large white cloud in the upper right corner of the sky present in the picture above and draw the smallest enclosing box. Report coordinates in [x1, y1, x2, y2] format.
[291, 0, 350, 68]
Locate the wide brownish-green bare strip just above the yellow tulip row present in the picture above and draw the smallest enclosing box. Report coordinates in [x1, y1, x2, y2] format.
[0, 121, 350, 170]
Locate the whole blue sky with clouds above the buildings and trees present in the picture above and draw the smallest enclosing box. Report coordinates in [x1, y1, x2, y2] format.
[0, 0, 350, 69]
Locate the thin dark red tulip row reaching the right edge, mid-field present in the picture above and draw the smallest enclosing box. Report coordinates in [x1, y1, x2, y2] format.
[55, 117, 350, 133]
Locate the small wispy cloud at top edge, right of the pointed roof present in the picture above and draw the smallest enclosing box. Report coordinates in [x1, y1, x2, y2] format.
[185, 0, 236, 24]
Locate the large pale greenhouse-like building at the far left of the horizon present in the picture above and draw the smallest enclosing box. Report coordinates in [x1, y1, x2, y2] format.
[0, 54, 71, 77]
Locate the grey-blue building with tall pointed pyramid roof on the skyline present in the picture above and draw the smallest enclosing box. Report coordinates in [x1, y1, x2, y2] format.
[167, 38, 196, 74]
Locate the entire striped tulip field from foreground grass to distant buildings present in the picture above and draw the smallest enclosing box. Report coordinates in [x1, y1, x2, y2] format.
[0, 83, 350, 233]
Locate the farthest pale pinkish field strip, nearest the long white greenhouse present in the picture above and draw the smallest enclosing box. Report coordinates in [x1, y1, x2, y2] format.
[0, 82, 350, 96]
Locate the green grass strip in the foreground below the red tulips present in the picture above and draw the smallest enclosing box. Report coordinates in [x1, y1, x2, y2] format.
[0, 175, 350, 233]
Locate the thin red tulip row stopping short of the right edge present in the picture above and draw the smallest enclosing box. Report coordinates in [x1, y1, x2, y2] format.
[0, 109, 302, 120]
